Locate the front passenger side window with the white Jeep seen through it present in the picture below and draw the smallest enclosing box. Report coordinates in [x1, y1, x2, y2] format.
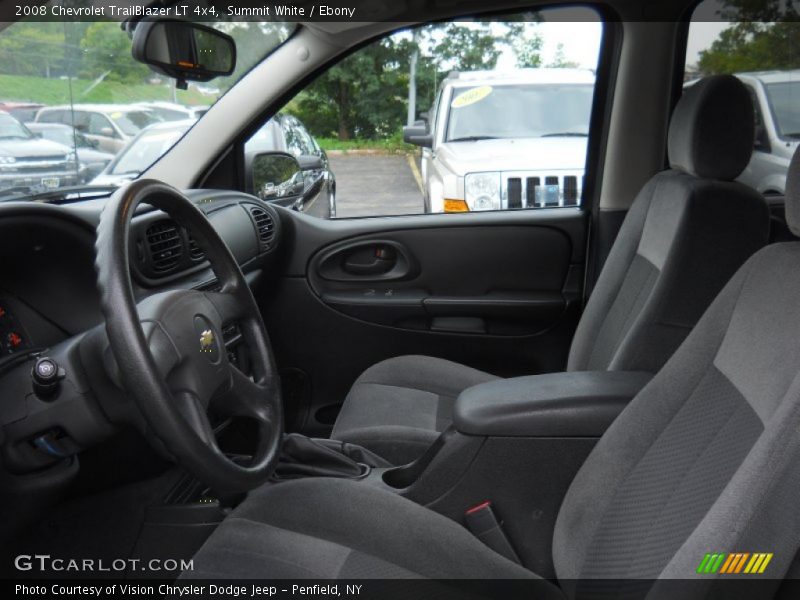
[244, 7, 603, 218]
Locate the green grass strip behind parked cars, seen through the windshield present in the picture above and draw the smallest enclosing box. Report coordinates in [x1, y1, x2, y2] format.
[0, 75, 215, 105]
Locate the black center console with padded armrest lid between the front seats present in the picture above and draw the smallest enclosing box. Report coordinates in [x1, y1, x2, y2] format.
[308, 371, 651, 577]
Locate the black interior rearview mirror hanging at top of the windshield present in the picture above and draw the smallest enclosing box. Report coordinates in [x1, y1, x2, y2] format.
[132, 20, 236, 87]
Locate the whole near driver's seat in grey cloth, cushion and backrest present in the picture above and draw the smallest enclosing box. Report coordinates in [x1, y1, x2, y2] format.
[184, 83, 800, 600]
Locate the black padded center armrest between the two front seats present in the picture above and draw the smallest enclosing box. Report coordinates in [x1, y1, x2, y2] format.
[453, 371, 652, 437]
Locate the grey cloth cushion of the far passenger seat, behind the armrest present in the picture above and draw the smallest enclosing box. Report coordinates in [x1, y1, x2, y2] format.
[331, 356, 497, 464]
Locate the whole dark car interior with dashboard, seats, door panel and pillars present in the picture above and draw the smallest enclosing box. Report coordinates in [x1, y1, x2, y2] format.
[0, 0, 800, 599]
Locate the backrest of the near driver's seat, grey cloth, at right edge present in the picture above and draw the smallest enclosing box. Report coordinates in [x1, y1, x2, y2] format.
[553, 148, 800, 598]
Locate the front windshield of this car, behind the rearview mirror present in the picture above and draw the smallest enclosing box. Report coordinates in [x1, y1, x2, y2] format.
[0, 11, 296, 200]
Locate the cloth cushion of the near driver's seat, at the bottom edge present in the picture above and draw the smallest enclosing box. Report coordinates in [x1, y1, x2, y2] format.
[188, 478, 562, 598]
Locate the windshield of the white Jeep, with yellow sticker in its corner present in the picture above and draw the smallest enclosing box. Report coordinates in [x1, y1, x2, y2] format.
[445, 84, 594, 142]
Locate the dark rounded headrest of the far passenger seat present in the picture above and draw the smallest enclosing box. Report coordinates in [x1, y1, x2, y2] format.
[667, 75, 755, 181]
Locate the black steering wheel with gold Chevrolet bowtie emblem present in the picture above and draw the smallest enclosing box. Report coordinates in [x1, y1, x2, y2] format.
[95, 179, 283, 491]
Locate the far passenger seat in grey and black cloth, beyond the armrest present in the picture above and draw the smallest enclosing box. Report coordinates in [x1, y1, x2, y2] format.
[331, 76, 769, 464]
